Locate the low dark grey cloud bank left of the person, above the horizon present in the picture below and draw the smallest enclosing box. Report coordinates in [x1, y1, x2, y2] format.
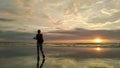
[0, 31, 34, 41]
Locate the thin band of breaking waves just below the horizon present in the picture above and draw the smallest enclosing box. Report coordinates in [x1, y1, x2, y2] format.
[0, 42, 120, 47]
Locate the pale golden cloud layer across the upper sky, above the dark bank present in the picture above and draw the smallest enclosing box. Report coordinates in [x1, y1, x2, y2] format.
[0, 0, 119, 30]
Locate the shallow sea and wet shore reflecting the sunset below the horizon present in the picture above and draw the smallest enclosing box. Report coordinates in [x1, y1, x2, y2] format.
[0, 42, 120, 68]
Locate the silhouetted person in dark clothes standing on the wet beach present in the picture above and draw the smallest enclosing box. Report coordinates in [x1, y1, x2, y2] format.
[33, 30, 45, 62]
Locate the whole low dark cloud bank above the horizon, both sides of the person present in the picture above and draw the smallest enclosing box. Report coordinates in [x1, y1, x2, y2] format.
[0, 28, 120, 41]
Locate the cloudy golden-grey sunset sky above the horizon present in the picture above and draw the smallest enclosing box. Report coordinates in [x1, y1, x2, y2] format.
[0, 0, 120, 42]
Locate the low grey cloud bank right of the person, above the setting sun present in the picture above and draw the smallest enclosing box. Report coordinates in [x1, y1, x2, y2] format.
[46, 28, 120, 40]
